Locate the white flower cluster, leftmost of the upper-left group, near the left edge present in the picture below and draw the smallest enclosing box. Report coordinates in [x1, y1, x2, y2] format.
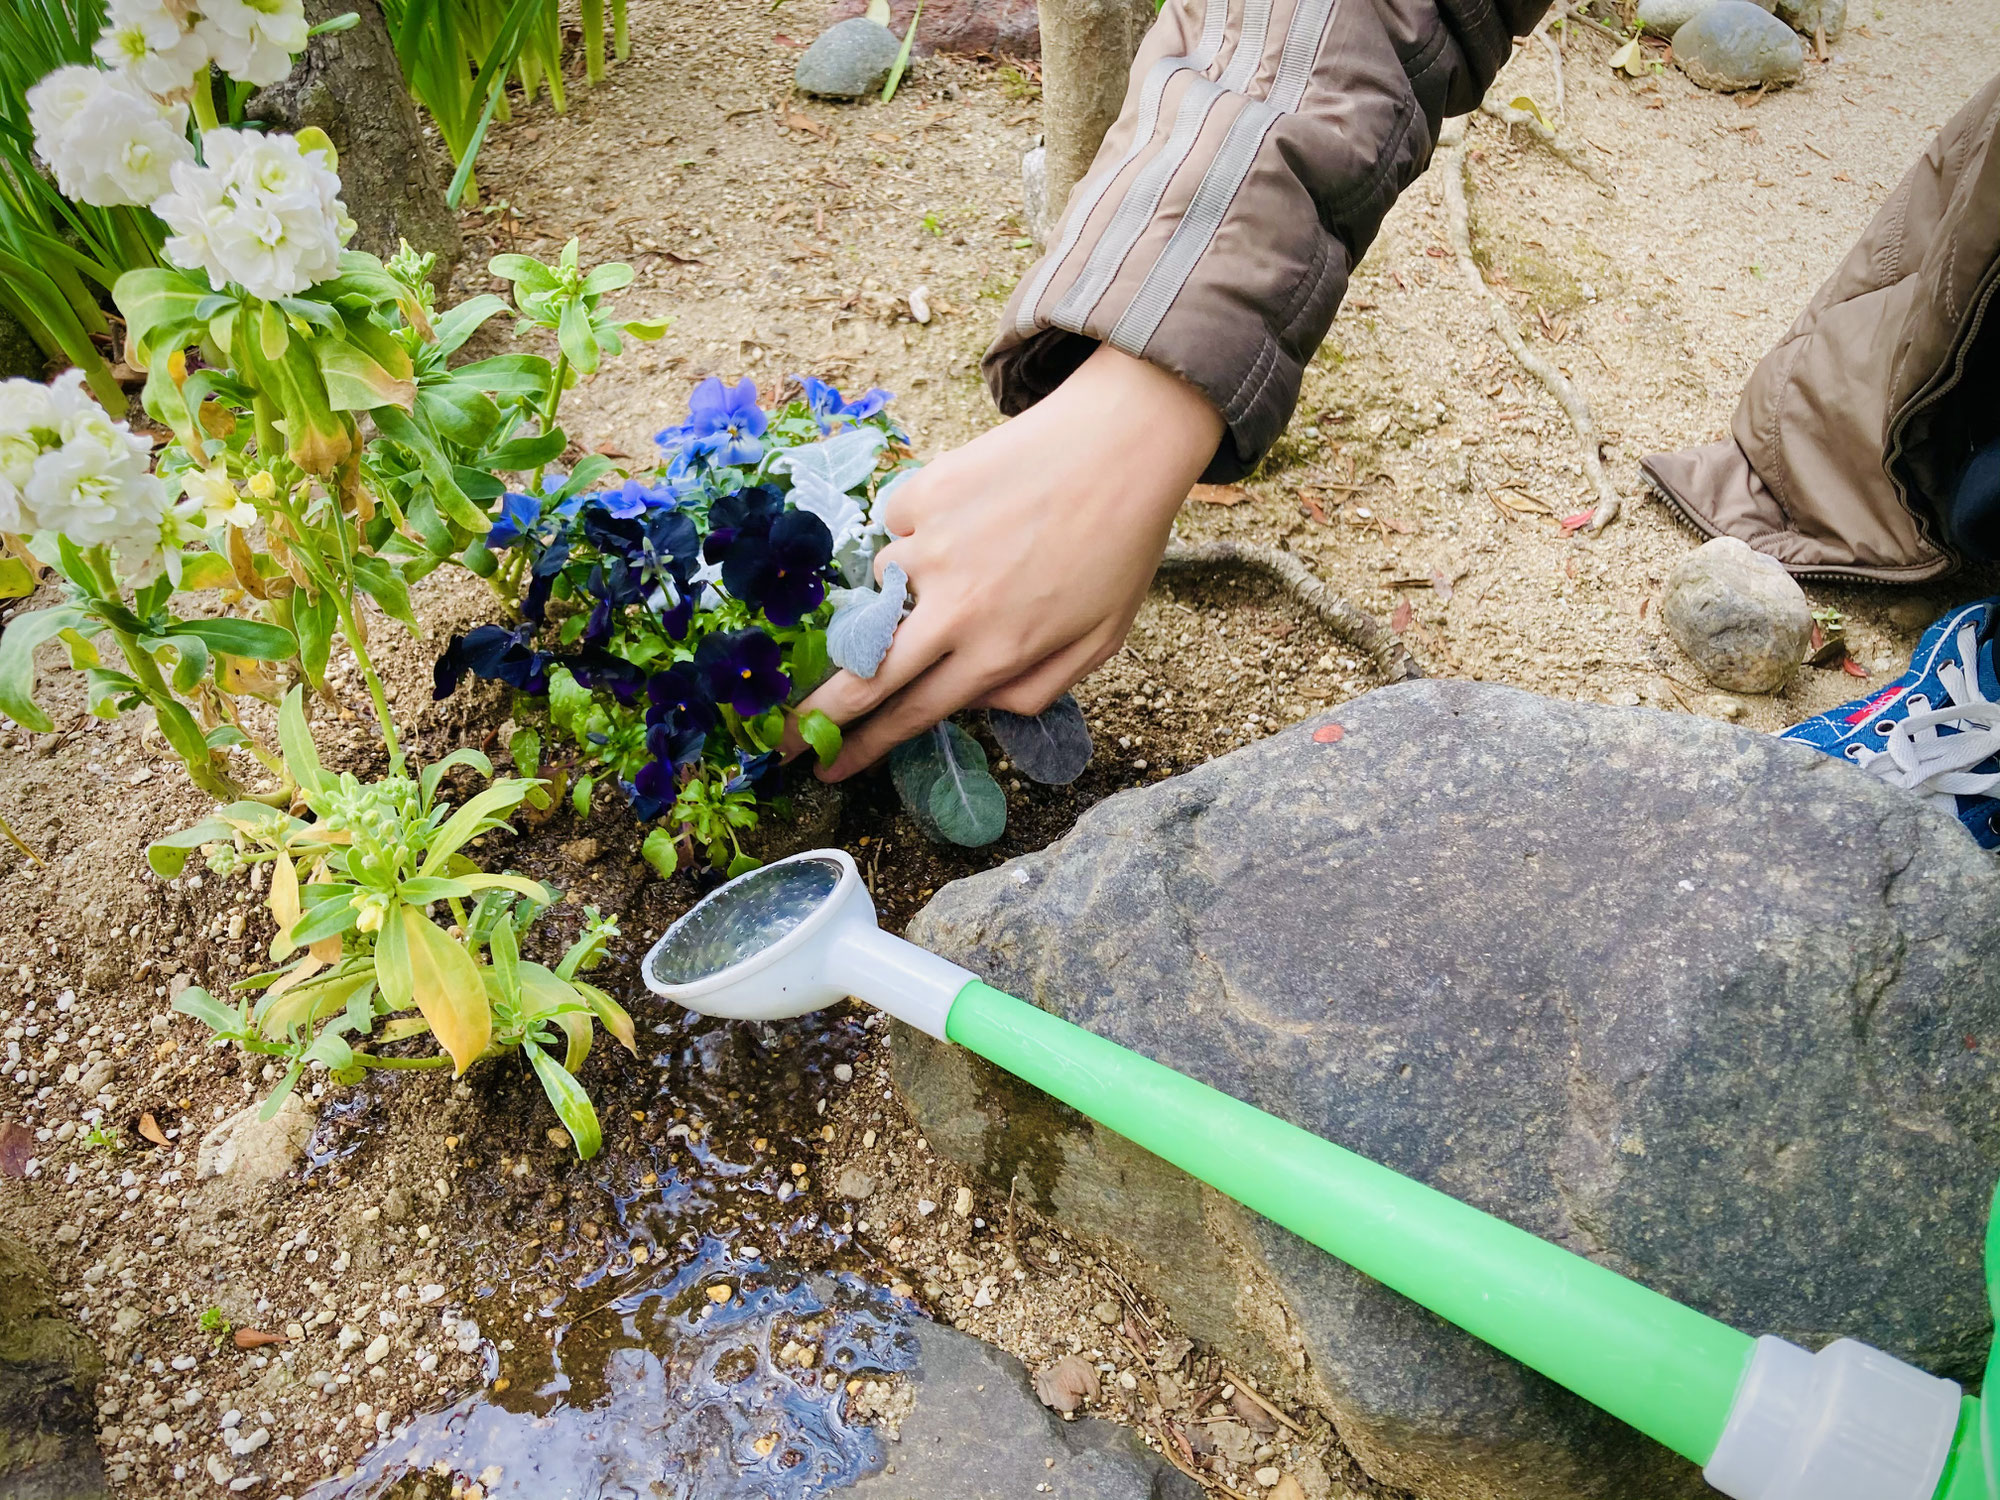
[28, 64, 194, 208]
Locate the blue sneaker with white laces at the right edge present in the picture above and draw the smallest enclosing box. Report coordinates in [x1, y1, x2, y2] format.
[1778, 598, 2000, 850]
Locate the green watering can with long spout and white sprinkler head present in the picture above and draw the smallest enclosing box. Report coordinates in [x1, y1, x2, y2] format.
[644, 850, 2000, 1500]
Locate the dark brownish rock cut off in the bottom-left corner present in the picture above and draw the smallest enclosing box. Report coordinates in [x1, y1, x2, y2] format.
[0, 1236, 110, 1500]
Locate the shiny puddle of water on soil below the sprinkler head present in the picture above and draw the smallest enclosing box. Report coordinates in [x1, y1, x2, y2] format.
[310, 968, 924, 1500]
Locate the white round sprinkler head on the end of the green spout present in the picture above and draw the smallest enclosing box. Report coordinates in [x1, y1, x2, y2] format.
[644, 848, 974, 1038]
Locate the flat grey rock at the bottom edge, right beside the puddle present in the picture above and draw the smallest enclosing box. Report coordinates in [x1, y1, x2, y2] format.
[838, 1324, 1202, 1500]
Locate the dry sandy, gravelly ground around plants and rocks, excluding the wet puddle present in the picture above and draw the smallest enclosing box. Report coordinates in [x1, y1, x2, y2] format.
[0, 0, 2000, 1496]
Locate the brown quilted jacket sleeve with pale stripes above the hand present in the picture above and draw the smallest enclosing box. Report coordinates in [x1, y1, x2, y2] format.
[986, 0, 1548, 482]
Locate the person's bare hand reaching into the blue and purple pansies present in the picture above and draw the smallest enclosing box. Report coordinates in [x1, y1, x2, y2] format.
[800, 346, 1222, 782]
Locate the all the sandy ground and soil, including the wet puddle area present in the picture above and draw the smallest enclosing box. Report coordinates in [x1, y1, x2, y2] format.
[0, 0, 2000, 1500]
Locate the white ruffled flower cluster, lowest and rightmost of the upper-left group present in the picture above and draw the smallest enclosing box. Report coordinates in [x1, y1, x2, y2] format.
[152, 130, 354, 298]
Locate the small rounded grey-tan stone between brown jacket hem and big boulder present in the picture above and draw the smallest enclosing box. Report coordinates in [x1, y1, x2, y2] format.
[1660, 536, 1812, 692]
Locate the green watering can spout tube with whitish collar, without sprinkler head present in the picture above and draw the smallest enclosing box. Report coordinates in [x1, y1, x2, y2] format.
[946, 980, 1976, 1500]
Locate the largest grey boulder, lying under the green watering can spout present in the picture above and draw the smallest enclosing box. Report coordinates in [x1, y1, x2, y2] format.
[892, 682, 2000, 1500]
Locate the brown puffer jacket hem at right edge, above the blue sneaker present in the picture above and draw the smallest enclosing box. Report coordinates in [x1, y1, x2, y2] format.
[1644, 78, 2000, 582]
